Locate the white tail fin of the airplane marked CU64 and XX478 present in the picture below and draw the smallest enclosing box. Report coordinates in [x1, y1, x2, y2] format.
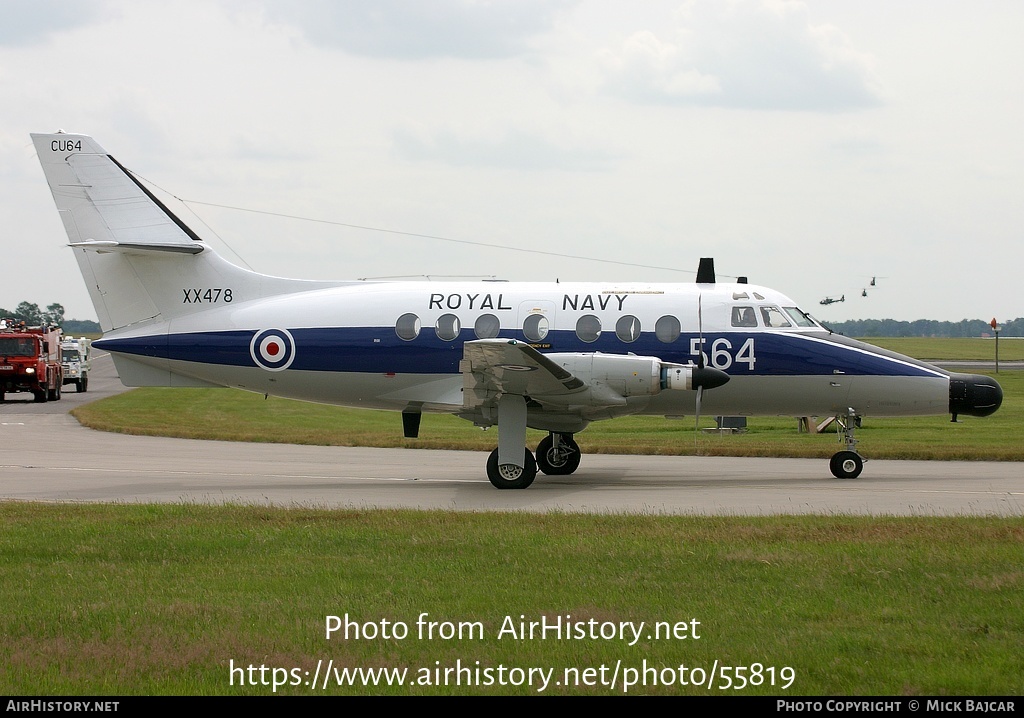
[32, 132, 341, 333]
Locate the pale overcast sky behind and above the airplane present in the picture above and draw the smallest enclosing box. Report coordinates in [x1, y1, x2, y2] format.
[0, 0, 1024, 322]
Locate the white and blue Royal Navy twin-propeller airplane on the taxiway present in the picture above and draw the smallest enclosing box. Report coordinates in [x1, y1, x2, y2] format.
[32, 132, 1002, 489]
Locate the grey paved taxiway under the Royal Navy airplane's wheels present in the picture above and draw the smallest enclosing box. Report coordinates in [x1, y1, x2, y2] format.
[0, 355, 1024, 516]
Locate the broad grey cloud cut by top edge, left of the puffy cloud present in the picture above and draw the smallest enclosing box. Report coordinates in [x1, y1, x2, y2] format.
[265, 0, 567, 59]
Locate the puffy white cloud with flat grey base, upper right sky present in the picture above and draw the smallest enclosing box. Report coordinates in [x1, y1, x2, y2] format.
[601, 0, 881, 112]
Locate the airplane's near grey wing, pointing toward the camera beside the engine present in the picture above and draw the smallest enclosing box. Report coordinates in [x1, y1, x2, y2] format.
[459, 339, 587, 408]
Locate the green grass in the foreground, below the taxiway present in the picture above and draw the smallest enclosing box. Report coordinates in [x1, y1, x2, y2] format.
[0, 503, 1024, 695]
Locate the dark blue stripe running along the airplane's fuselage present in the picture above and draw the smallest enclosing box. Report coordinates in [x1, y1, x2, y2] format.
[94, 327, 942, 377]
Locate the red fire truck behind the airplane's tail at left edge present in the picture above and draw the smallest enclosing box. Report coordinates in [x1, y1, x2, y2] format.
[0, 320, 63, 402]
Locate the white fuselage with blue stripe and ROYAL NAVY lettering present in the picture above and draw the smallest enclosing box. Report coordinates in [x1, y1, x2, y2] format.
[90, 282, 983, 425]
